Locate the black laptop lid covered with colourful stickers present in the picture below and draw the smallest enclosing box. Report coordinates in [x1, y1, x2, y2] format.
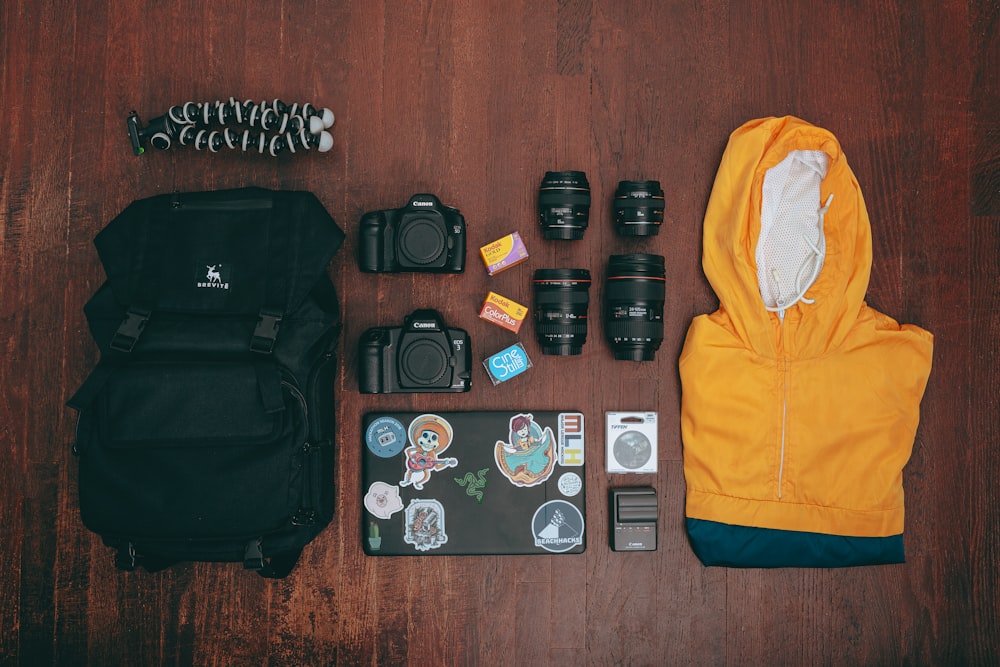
[361, 410, 587, 556]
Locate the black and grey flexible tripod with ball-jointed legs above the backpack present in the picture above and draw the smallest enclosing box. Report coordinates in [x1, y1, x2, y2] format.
[126, 97, 334, 156]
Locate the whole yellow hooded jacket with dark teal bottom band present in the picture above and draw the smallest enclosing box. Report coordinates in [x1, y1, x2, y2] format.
[680, 117, 933, 567]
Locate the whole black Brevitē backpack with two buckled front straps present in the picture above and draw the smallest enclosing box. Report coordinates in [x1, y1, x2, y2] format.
[68, 188, 344, 577]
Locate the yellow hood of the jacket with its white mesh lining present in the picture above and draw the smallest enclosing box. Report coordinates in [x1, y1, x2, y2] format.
[703, 116, 872, 358]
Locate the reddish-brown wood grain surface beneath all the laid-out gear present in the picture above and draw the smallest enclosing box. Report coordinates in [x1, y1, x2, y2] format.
[0, 0, 1000, 665]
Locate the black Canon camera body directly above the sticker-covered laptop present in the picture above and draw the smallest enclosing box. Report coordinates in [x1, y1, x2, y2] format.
[358, 309, 472, 394]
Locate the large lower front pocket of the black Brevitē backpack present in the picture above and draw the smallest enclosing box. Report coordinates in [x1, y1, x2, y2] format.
[78, 363, 308, 539]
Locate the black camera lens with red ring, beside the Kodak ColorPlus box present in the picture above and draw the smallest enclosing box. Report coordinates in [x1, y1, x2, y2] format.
[534, 269, 590, 355]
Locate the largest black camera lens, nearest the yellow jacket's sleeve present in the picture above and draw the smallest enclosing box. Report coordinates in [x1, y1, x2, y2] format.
[604, 253, 666, 361]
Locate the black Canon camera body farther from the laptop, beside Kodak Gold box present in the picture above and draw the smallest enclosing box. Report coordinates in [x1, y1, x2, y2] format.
[358, 194, 465, 273]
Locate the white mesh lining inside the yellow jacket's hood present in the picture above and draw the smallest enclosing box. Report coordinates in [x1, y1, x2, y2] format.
[756, 151, 829, 315]
